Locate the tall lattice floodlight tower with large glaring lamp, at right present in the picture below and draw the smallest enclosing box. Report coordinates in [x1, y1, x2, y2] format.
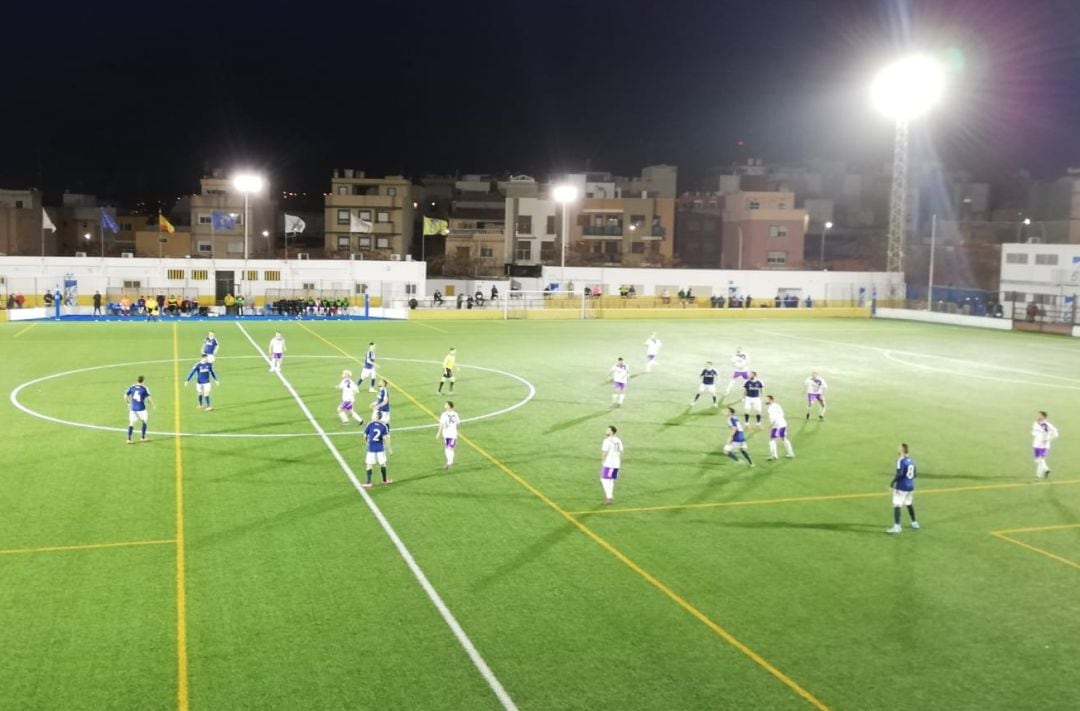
[870, 54, 945, 272]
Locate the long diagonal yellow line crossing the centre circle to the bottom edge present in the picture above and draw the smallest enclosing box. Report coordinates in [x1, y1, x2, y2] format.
[299, 323, 828, 711]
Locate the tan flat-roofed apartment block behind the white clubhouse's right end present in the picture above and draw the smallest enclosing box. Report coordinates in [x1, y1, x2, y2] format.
[325, 169, 415, 259]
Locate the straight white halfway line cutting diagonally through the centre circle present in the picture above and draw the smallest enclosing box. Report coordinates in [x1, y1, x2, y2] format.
[237, 323, 517, 711]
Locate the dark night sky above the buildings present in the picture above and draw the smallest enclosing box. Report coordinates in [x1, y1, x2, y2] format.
[0, 0, 1080, 201]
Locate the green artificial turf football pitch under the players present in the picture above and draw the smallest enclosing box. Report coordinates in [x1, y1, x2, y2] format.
[0, 320, 1080, 709]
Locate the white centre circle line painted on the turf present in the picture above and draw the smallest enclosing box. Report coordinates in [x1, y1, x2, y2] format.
[10, 356, 537, 439]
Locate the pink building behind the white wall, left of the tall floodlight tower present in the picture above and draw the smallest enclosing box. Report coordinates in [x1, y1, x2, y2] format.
[720, 190, 809, 269]
